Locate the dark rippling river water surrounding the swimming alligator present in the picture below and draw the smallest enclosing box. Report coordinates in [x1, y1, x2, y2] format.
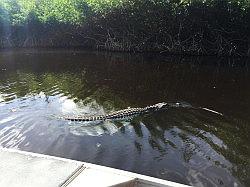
[0, 50, 250, 186]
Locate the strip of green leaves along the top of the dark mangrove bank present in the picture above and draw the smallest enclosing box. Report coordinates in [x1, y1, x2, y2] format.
[0, 0, 250, 25]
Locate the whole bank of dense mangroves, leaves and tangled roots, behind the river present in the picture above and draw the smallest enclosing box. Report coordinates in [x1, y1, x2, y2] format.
[0, 0, 250, 55]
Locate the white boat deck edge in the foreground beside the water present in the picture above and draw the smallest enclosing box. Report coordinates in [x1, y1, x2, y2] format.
[0, 148, 187, 187]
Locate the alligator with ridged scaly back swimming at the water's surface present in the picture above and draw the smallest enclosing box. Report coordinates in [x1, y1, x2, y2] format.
[60, 102, 181, 122]
